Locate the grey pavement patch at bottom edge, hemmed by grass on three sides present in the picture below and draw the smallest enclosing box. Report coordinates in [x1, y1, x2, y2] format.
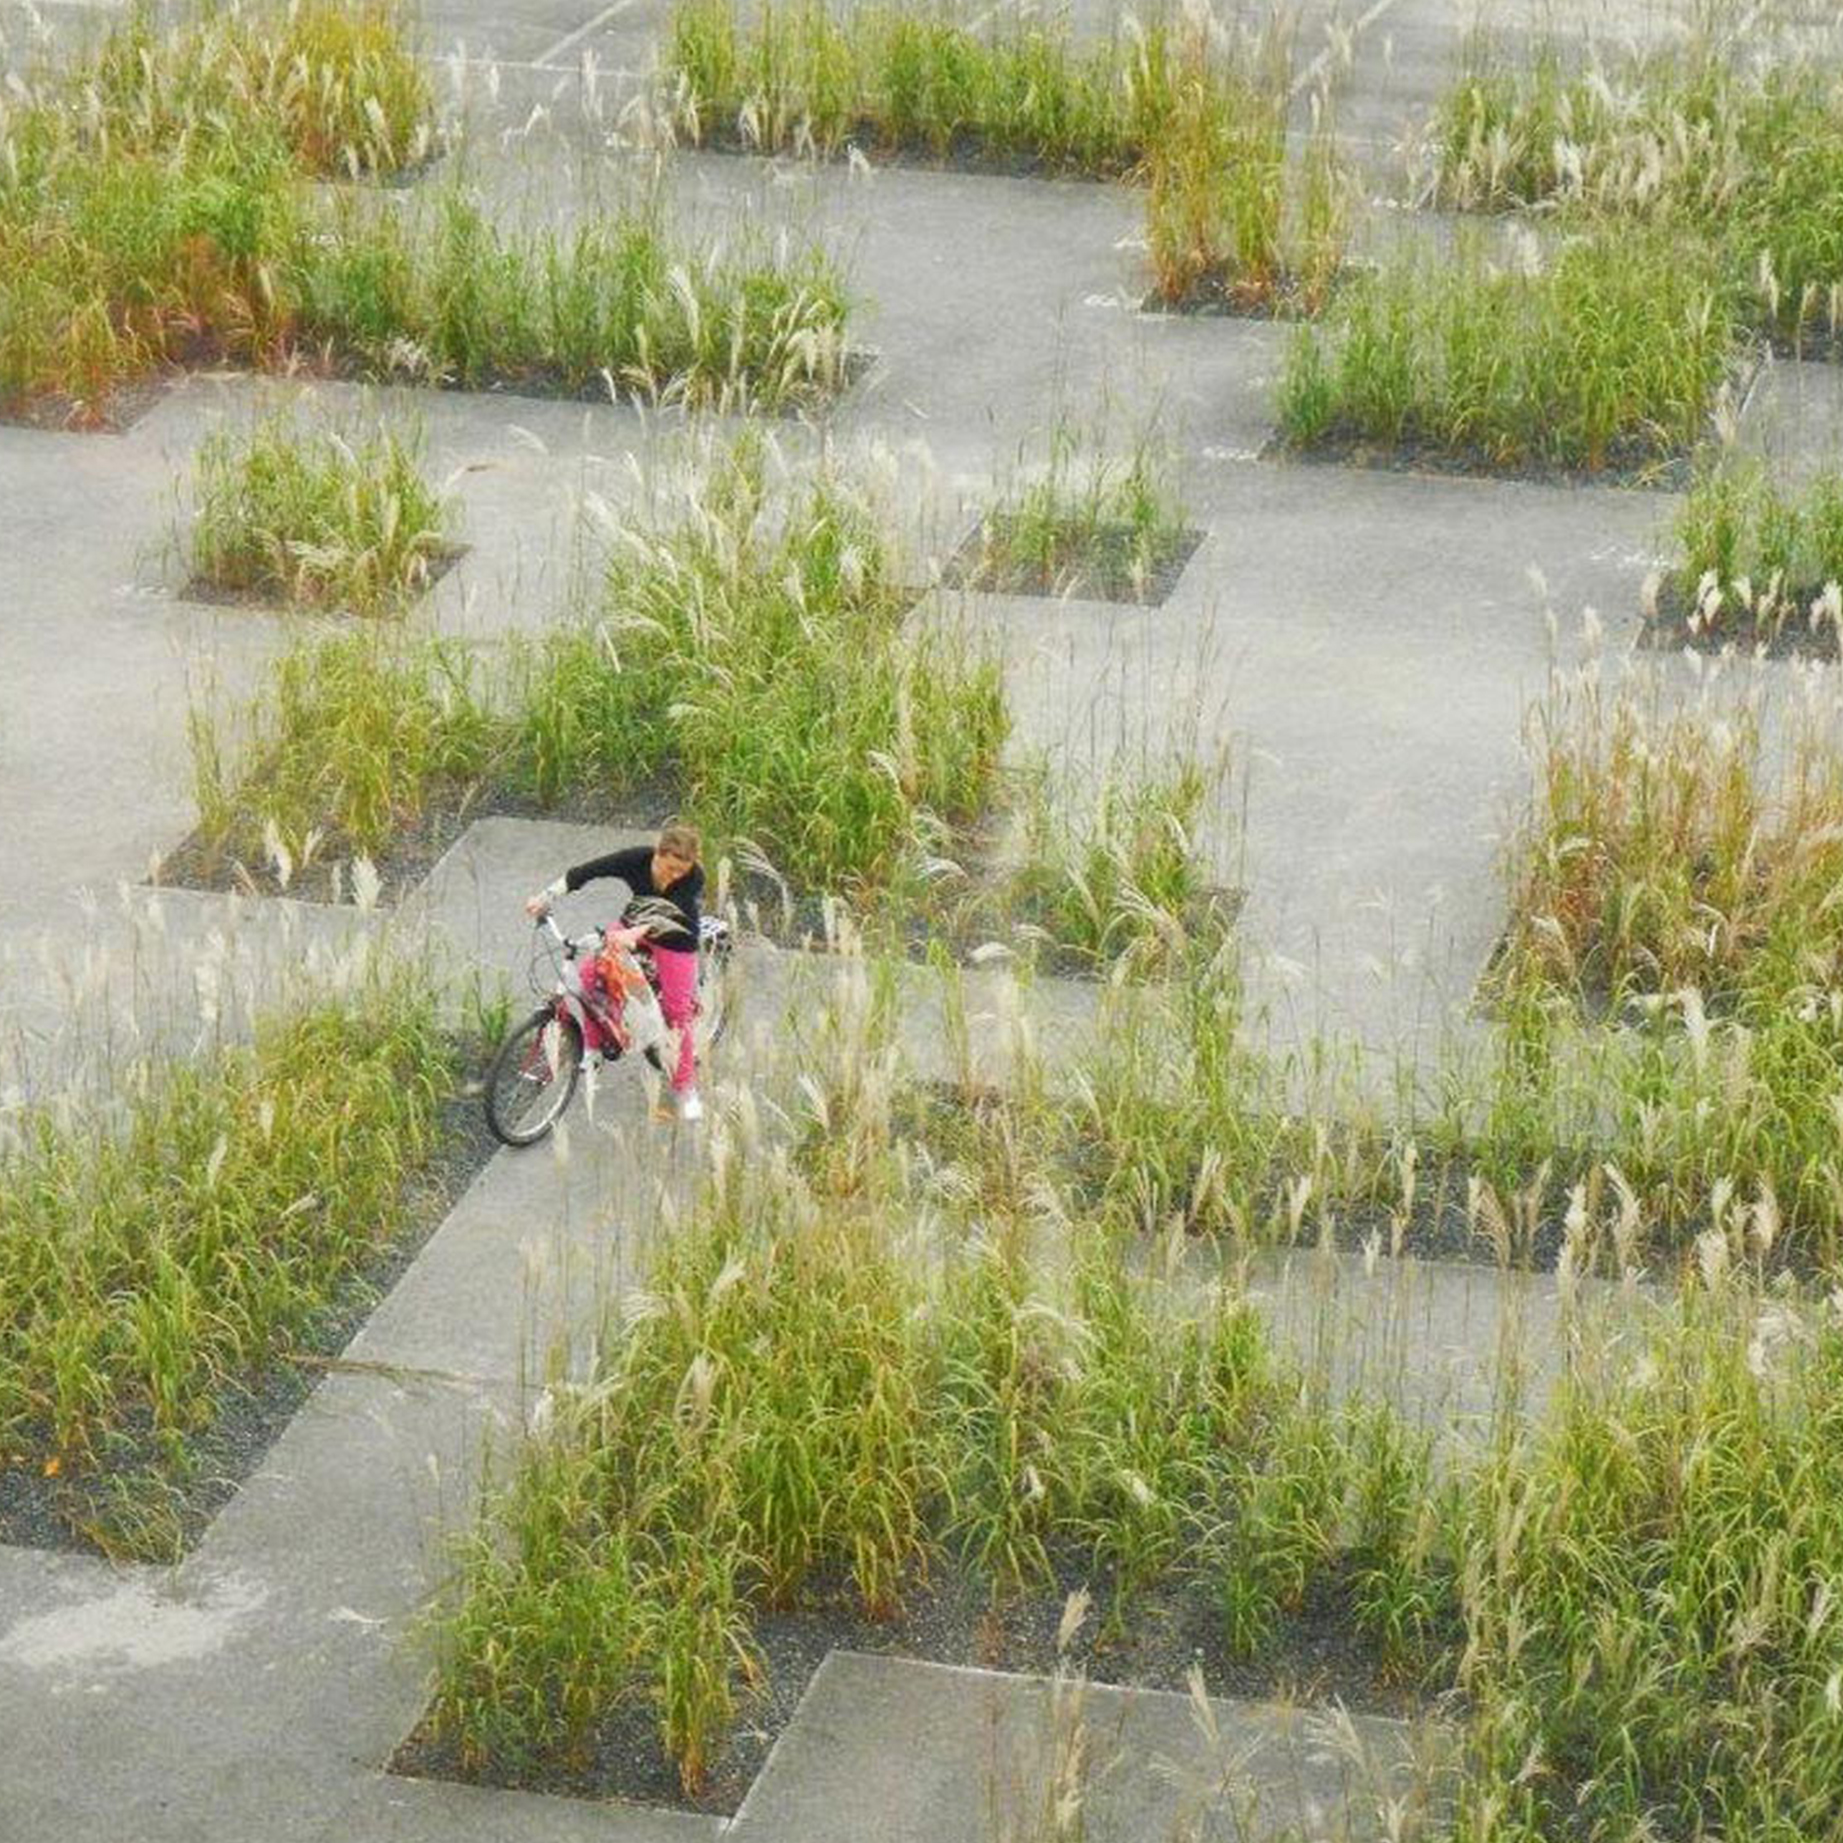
[732, 1651, 1444, 1843]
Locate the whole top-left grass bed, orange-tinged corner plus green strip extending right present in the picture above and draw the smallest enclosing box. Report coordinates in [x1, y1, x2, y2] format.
[0, 4, 846, 422]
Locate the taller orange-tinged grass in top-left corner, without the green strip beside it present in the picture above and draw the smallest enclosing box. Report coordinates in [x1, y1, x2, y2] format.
[0, 0, 422, 415]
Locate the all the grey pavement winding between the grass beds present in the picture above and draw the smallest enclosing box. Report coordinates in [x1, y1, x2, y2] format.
[0, 0, 1836, 1843]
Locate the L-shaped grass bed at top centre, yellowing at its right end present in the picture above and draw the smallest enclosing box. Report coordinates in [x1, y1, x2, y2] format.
[665, 0, 1349, 313]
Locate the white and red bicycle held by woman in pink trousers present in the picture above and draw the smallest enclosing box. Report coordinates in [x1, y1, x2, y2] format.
[481, 912, 734, 1146]
